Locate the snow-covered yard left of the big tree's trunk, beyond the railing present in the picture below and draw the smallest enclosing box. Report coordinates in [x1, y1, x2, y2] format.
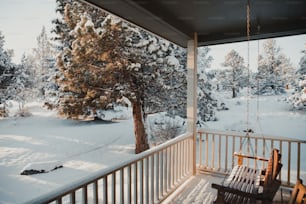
[0, 103, 134, 203]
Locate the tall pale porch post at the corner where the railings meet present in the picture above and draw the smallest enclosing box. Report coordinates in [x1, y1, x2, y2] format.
[187, 33, 198, 175]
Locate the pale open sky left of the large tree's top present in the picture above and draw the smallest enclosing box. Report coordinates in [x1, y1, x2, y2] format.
[0, 0, 56, 63]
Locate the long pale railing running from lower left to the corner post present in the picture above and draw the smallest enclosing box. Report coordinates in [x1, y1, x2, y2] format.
[26, 134, 194, 204]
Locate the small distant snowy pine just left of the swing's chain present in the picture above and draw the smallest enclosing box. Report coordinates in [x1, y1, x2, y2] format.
[222, 50, 246, 98]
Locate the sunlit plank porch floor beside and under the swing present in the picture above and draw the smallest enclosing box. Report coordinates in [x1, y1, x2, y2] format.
[163, 173, 290, 204]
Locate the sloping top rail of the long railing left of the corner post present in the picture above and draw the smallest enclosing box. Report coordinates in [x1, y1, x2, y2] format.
[25, 133, 192, 204]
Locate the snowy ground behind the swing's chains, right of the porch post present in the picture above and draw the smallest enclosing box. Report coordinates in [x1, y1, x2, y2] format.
[206, 90, 306, 140]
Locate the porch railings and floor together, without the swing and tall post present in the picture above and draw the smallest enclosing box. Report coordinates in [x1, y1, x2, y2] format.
[27, 130, 306, 204]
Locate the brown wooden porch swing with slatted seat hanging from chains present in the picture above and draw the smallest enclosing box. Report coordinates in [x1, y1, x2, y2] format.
[212, 149, 283, 203]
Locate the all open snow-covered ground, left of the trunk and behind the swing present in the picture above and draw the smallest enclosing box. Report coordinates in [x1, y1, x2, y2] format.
[0, 95, 306, 203]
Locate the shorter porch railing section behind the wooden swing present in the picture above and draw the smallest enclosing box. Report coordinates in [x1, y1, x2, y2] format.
[197, 130, 306, 186]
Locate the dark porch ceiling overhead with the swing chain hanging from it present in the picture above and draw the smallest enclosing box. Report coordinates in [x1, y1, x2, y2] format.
[85, 0, 306, 47]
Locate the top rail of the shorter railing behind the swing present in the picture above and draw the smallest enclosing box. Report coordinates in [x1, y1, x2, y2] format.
[198, 129, 306, 144]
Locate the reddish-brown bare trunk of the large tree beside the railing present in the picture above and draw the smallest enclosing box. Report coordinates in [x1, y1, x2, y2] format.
[132, 100, 149, 154]
